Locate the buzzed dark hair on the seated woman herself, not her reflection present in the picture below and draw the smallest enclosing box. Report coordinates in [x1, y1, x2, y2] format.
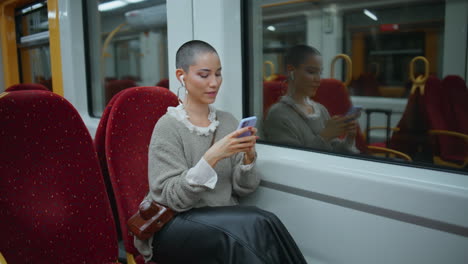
[176, 40, 218, 72]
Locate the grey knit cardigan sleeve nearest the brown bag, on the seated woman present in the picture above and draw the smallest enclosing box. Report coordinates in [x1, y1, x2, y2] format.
[148, 117, 210, 212]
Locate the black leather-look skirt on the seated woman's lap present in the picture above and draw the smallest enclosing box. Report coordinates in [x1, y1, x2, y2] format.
[153, 206, 307, 264]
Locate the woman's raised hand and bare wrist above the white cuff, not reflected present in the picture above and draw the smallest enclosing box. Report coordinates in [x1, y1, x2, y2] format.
[203, 127, 257, 168]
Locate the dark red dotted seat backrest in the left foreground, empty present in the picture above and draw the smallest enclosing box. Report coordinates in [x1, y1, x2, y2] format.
[0, 91, 118, 263]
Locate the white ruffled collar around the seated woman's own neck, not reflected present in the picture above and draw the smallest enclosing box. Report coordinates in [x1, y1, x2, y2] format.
[167, 104, 219, 136]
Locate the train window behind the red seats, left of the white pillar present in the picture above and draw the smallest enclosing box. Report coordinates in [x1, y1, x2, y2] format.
[84, 0, 168, 117]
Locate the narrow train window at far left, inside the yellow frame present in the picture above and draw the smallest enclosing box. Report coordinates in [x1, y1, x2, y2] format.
[15, 1, 52, 90]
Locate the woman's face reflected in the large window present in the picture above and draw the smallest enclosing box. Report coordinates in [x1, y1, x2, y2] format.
[293, 55, 322, 97]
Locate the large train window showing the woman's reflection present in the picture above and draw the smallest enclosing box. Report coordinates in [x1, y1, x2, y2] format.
[242, 0, 468, 172]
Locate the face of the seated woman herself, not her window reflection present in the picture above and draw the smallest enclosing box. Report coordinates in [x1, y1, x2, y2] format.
[184, 52, 223, 104]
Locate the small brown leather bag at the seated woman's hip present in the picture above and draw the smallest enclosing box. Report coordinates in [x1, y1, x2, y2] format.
[127, 200, 175, 240]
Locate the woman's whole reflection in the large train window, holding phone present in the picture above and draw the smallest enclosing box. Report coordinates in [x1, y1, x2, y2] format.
[264, 45, 358, 153]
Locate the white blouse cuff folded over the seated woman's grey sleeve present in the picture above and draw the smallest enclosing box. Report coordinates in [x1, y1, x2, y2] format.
[185, 158, 218, 189]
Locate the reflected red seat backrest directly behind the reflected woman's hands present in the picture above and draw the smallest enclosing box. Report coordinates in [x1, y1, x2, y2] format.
[313, 79, 367, 153]
